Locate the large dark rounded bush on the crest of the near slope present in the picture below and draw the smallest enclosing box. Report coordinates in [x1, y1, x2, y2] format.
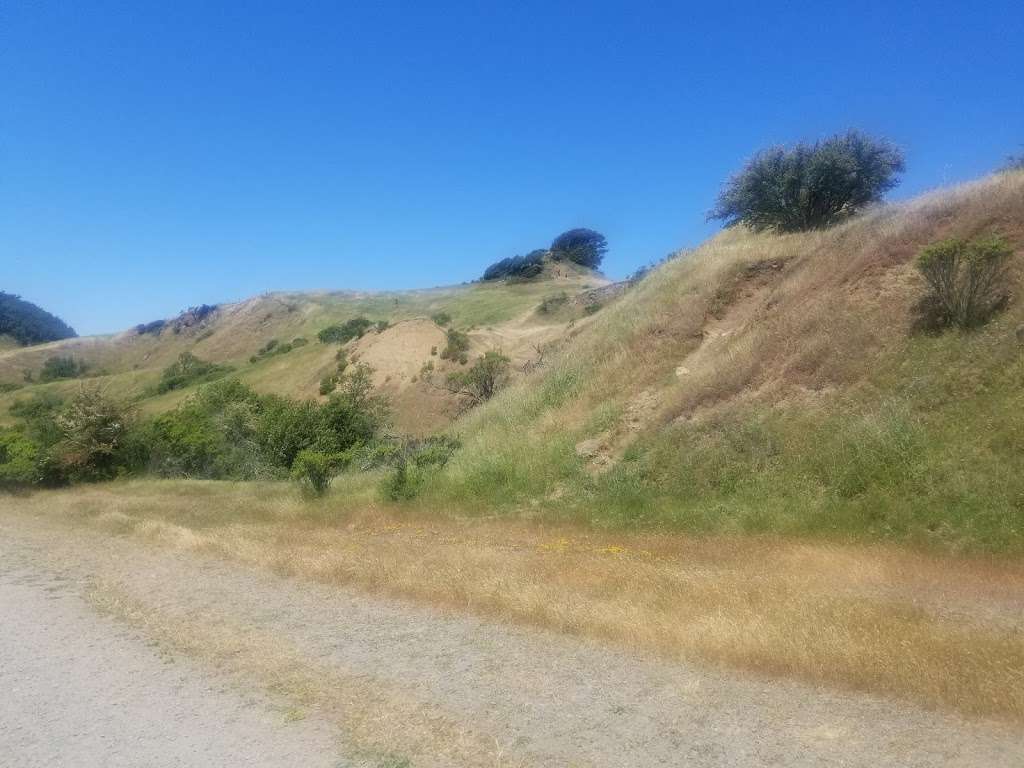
[709, 131, 904, 232]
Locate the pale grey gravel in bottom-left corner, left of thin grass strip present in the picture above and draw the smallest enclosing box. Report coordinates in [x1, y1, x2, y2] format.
[0, 538, 341, 768]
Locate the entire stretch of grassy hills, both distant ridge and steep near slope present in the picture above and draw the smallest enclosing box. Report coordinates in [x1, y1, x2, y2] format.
[0, 172, 1024, 551]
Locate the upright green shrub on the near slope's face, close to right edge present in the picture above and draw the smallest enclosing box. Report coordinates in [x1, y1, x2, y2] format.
[916, 237, 1013, 330]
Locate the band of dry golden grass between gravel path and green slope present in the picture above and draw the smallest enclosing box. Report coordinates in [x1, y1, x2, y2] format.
[5, 482, 1024, 723]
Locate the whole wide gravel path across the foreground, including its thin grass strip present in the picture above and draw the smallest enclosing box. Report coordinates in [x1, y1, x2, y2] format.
[0, 514, 1024, 768]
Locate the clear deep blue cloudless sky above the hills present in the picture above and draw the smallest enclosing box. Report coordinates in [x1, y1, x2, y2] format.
[0, 0, 1024, 333]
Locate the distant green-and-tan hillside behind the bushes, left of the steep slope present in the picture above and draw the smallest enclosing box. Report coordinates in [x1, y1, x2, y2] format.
[0, 264, 606, 432]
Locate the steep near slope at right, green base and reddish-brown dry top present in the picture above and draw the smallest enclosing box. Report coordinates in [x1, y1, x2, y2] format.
[422, 173, 1024, 551]
